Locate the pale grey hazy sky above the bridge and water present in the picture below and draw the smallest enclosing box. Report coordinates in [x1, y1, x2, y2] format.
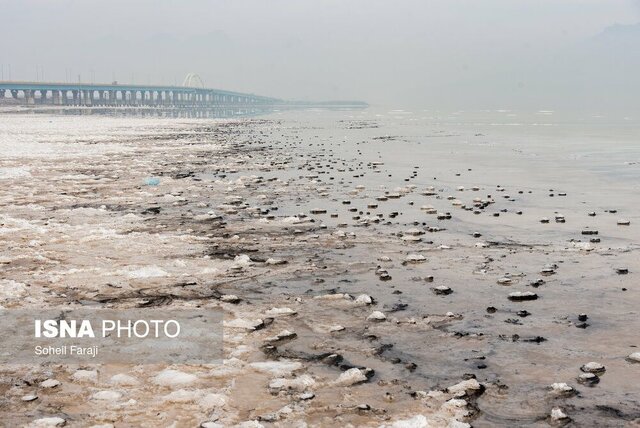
[0, 0, 640, 109]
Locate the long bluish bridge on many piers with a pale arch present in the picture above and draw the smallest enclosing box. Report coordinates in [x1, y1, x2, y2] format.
[0, 73, 284, 109]
